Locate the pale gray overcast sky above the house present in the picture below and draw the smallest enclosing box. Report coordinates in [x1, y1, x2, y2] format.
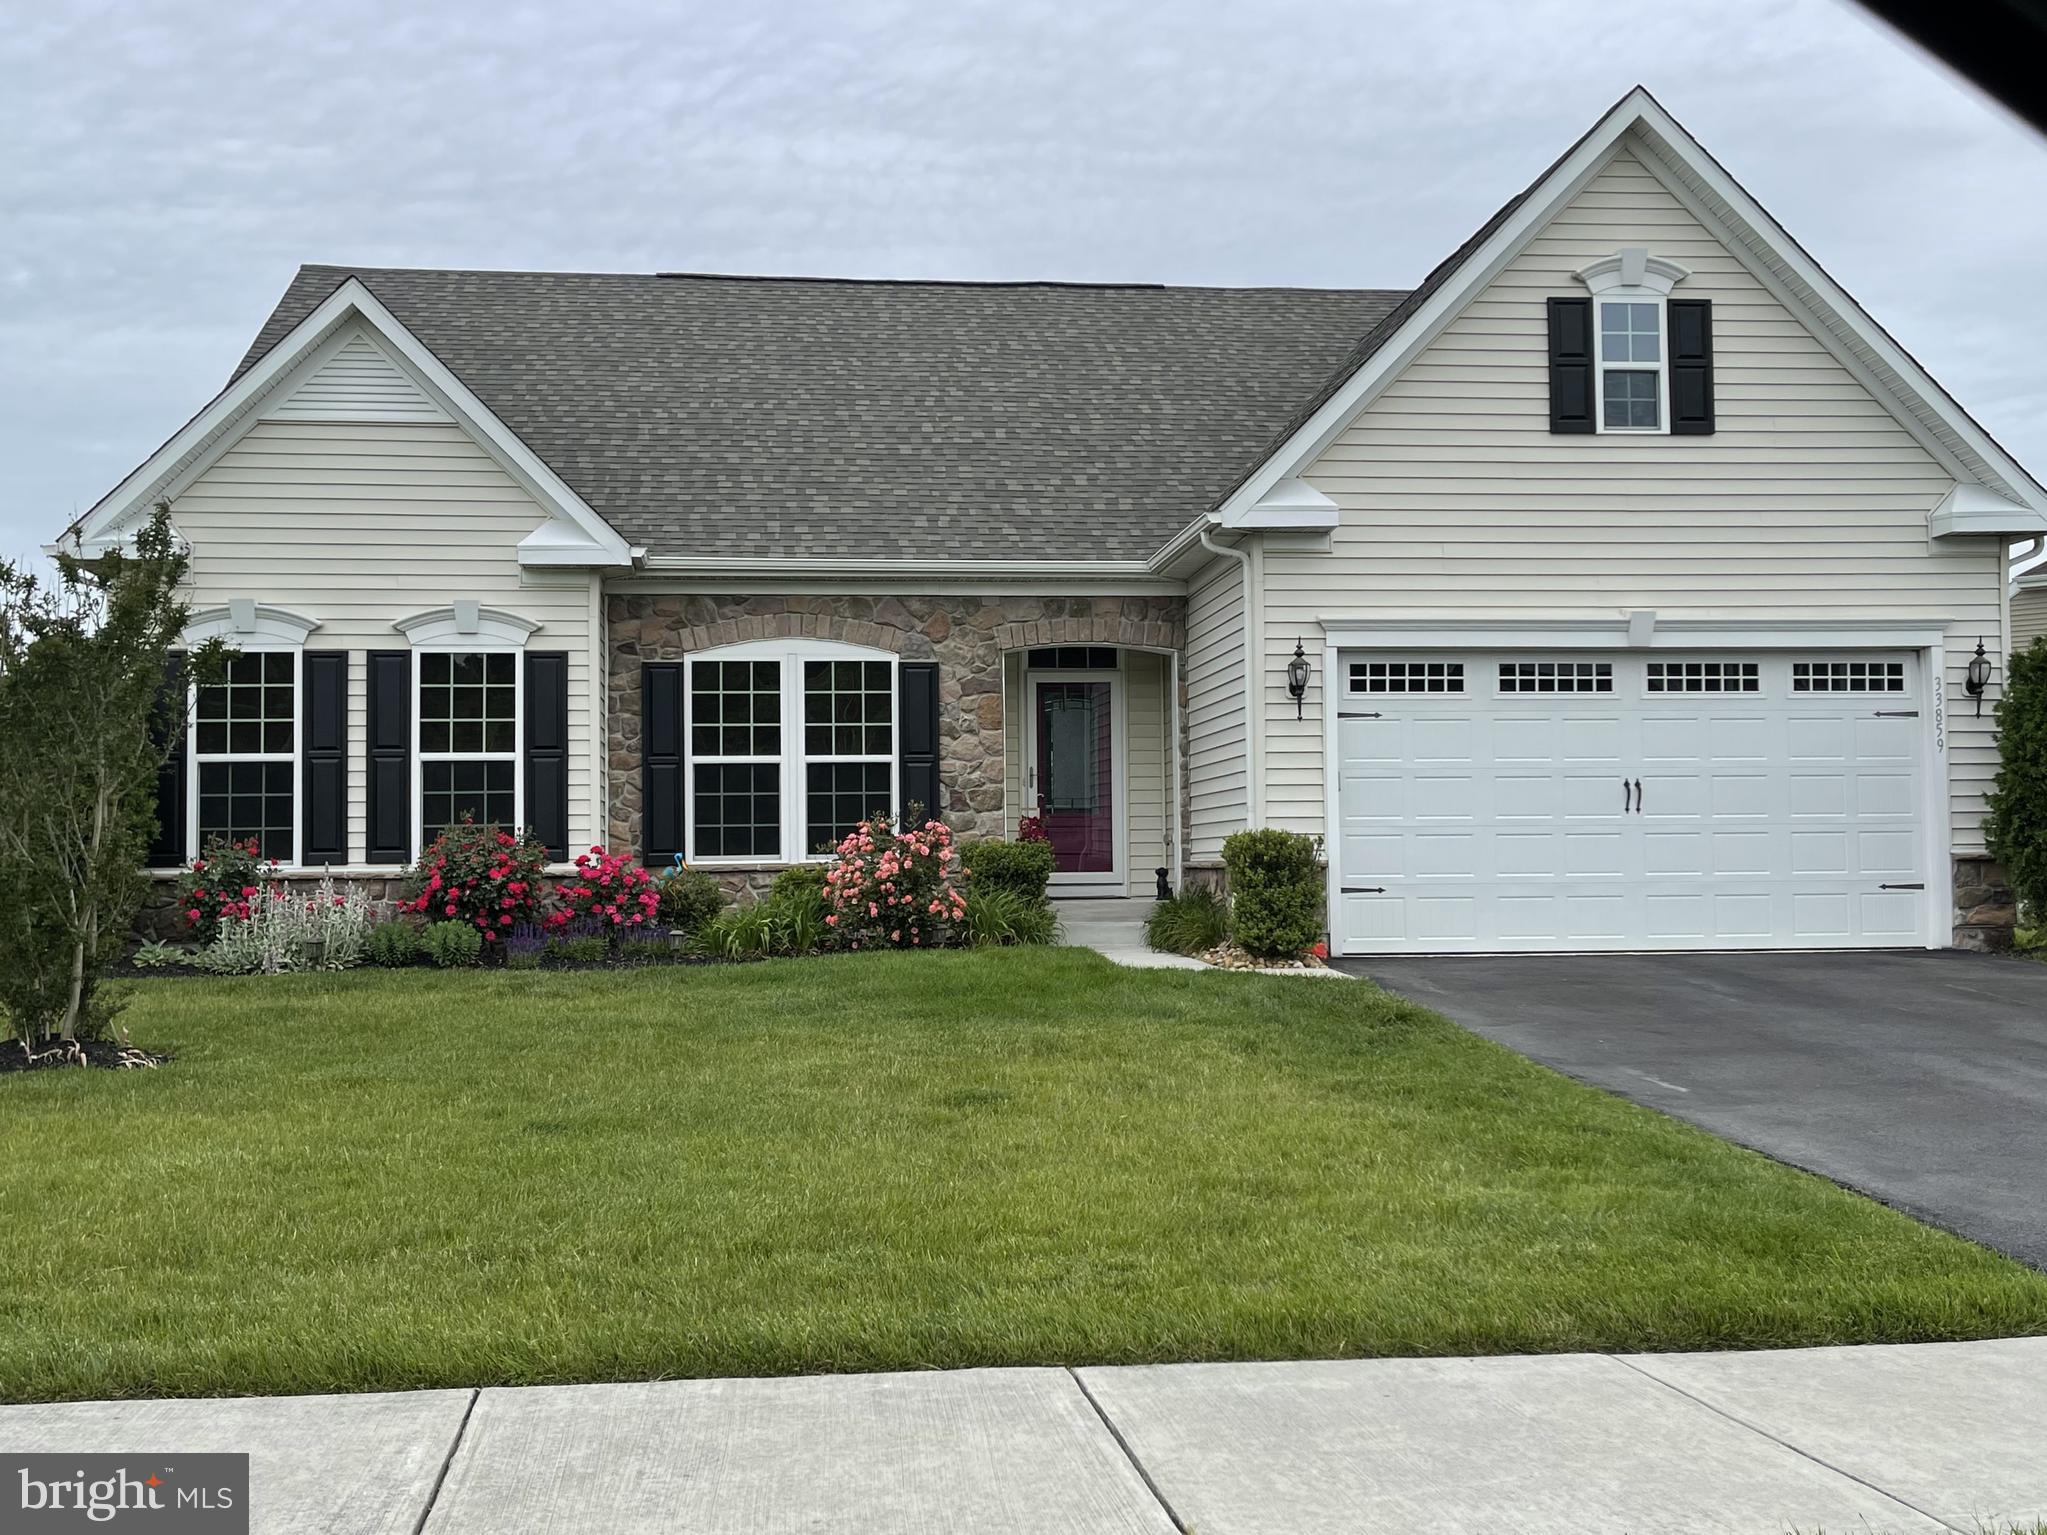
[0, 0, 2047, 573]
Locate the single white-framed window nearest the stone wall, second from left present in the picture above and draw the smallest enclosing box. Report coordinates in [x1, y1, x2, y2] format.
[413, 649, 520, 847]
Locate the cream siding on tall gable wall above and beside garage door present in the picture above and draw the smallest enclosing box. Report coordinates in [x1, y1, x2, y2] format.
[1261, 149, 2004, 853]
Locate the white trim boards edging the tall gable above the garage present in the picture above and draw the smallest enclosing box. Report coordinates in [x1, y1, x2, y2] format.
[1203, 86, 2047, 546]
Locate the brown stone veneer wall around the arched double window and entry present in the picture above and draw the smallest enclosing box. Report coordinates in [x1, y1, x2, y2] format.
[606, 591, 1187, 888]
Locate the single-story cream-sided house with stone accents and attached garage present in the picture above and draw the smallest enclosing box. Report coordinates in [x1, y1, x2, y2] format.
[51, 90, 2047, 954]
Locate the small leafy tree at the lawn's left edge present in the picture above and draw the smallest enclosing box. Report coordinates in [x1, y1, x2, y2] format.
[0, 506, 223, 1040]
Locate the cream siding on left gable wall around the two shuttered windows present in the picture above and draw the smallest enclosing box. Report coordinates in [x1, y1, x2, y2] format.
[172, 420, 602, 862]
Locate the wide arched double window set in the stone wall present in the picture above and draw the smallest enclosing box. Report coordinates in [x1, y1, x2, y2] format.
[684, 641, 897, 864]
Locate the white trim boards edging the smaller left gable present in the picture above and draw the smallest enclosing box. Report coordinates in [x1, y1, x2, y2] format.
[63, 278, 633, 565]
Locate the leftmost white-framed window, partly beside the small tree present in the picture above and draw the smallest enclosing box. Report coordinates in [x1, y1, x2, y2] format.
[190, 651, 299, 864]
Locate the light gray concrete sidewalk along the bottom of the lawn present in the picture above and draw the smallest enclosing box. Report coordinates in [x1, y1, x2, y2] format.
[0, 1339, 2047, 1535]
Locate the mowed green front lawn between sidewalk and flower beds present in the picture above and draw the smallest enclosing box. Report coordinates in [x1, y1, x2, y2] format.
[0, 950, 2047, 1400]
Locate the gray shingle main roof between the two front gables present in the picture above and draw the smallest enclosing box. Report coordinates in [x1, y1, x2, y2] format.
[237, 266, 1408, 559]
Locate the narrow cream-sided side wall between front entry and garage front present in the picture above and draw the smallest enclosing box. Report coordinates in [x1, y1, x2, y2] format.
[1185, 559, 1244, 864]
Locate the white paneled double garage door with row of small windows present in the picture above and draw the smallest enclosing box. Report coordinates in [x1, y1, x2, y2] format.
[1335, 651, 1930, 954]
